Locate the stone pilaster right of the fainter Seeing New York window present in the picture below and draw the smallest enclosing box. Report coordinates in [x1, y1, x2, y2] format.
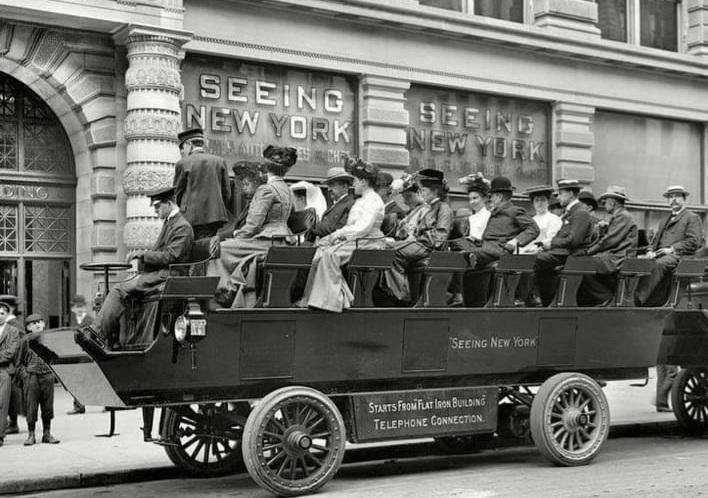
[553, 102, 595, 184]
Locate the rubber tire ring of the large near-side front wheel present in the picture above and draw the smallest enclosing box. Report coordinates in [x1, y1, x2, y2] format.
[242, 386, 346, 496]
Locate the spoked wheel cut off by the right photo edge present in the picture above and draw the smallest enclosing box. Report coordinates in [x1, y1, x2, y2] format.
[671, 368, 708, 433]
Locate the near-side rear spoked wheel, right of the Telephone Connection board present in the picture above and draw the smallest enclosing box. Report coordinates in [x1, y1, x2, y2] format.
[530, 373, 610, 466]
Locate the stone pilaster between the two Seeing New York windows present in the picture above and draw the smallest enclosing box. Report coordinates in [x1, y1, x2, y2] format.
[361, 76, 411, 174]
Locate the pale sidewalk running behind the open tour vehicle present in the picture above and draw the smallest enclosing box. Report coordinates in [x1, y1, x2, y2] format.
[0, 370, 675, 494]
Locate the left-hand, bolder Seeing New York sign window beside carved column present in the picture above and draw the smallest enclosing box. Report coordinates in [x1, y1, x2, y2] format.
[182, 55, 356, 178]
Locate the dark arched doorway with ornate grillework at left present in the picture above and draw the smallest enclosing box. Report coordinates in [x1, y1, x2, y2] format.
[0, 73, 76, 327]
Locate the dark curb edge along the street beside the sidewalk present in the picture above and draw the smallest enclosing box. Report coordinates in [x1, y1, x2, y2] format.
[0, 420, 682, 495]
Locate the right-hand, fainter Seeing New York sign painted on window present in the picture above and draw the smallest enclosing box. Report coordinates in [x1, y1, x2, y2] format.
[406, 85, 550, 192]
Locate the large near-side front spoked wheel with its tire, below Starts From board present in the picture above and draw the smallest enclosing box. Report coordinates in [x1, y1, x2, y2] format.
[243, 386, 346, 496]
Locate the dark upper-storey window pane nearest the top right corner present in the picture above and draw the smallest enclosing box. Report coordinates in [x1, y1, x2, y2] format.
[639, 0, 678, 52]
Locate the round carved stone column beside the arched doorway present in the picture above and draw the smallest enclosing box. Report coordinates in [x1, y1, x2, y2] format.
[123, 30, 182, 253]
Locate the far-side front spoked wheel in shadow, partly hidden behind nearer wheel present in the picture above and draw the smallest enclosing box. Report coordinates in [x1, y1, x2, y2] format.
[165, 402, 250, 477]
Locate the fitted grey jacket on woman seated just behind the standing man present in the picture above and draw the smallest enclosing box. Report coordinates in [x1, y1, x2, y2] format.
[236, 177, 294, 239]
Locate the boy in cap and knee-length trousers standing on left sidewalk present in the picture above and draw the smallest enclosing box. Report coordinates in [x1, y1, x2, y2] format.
[24, 313, 59, 446]
